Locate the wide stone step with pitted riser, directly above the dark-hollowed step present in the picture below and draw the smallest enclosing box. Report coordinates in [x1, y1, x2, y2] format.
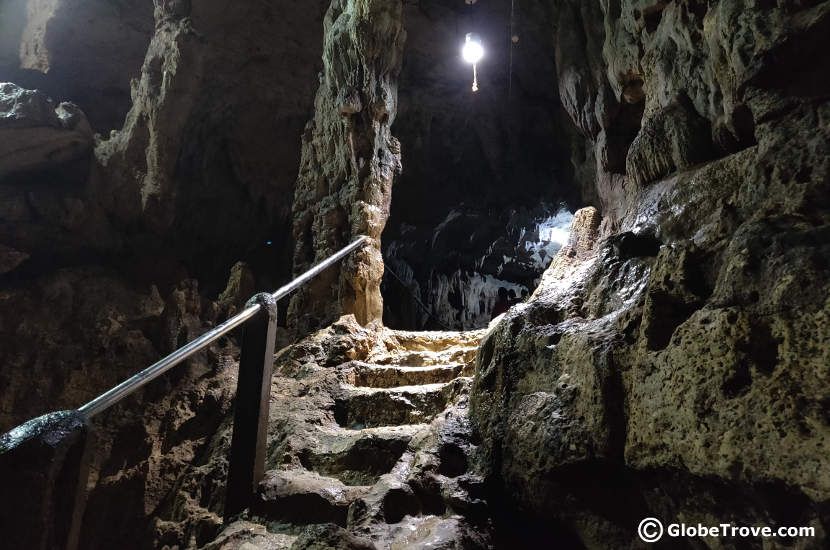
[334, 377, 472, 430]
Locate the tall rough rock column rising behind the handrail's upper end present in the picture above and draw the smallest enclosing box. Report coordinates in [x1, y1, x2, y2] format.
[289, 0, 406, 334]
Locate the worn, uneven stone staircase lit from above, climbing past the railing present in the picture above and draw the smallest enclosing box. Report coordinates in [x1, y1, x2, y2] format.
[203, 316, 490, 550]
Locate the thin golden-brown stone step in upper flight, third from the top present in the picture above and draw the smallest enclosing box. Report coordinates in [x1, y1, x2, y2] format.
[343, 361, 466, 388]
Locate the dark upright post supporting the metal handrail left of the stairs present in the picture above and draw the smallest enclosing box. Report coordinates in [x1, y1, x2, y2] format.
[225, 293, 277, 521]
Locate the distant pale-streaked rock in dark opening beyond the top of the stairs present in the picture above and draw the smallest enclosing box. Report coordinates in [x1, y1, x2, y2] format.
[382, 203, 572, 330]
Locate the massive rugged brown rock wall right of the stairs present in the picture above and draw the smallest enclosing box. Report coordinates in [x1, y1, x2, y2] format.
[472, 1, 830, 549]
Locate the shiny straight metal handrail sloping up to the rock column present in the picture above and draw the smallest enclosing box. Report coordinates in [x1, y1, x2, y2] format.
[78, 235, 369, 418]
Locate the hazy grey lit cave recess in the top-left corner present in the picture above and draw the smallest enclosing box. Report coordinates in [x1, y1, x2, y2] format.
[0, 0, 153, 134]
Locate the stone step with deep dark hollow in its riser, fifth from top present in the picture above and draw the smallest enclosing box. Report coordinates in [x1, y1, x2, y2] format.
[299, 424, 428, 485]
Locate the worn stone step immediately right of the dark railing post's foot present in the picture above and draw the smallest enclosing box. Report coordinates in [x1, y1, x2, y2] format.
[252, 468, 371, 527]
